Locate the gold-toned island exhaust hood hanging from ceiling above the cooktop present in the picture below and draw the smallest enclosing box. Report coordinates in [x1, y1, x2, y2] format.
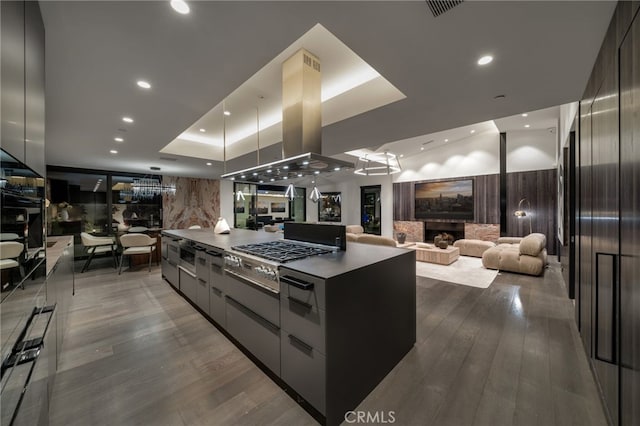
[221, 49, 354, 183]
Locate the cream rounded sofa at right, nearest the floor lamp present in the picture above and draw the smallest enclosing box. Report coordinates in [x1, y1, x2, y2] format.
[482, 233, 547, 276]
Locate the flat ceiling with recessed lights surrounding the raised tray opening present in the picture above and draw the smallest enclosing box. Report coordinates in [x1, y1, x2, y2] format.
[40, 0, 615, 177]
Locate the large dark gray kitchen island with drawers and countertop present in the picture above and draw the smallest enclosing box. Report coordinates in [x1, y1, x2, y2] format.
[163, 229, 416, 425]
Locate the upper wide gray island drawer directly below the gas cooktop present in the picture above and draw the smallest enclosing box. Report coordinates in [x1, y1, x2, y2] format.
[223, 271, 280, 327]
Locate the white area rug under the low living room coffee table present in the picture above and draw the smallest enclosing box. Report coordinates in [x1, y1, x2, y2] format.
[416, 256, 498, 288]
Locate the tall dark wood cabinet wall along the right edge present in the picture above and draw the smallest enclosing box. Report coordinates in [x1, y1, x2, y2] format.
[574, 2, 640, 426]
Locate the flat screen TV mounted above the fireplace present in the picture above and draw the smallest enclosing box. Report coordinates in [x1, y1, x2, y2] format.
[415, 179, 473, 220]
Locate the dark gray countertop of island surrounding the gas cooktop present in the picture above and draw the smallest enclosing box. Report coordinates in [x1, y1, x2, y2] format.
[162, 229, 415, 279]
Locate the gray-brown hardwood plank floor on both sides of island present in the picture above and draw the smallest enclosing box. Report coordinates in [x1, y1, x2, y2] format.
[50, 259, 606, 426]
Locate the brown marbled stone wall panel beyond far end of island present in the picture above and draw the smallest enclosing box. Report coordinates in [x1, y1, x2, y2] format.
[162, 176, 220, 229]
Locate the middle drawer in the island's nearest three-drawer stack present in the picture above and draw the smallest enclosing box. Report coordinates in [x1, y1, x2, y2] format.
[280, 295, 326, 354]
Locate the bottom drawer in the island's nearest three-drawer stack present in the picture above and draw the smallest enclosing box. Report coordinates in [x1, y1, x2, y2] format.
[280, 331, 326, 414]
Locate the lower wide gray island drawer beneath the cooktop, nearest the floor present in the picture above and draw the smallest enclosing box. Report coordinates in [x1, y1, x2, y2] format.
[227, 297, 280, 376]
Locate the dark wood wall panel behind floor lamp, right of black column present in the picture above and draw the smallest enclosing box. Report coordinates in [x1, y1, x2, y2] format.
[507, 169, 558, 255]
